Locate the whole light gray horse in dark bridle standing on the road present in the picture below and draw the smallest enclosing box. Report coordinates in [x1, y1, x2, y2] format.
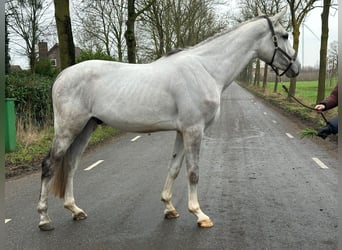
[37, 11, 300, 230]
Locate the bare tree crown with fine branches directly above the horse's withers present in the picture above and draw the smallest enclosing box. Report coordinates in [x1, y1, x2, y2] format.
[141, 0, 226, 59]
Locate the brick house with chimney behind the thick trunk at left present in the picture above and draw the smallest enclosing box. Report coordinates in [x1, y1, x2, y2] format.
[38, 41, 81, 70]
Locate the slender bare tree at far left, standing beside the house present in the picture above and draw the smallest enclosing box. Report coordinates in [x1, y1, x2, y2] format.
[6, 0, 51, 72]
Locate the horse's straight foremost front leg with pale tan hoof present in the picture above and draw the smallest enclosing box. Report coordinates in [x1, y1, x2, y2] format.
[183, 126, 214, 227]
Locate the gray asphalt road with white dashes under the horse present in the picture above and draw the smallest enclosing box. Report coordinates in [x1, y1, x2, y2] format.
[4, 84, 338, 250]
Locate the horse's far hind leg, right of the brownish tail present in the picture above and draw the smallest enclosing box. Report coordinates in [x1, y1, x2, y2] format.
[64, 119, 97, 220]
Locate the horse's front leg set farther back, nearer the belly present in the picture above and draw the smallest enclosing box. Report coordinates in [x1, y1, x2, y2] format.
[161, 132, 184, 219]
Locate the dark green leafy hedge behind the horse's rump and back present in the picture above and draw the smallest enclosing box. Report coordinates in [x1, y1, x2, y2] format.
[5, 50, 113, 128]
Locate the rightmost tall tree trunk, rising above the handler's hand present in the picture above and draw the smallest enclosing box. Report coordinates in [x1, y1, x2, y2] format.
[316, 0, 331, 103]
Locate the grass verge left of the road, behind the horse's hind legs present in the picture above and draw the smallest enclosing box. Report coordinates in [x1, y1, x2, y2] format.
[5, 125, 119, 178]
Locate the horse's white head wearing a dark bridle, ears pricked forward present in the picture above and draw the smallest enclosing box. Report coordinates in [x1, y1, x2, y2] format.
[259, 9, 300, 77]
